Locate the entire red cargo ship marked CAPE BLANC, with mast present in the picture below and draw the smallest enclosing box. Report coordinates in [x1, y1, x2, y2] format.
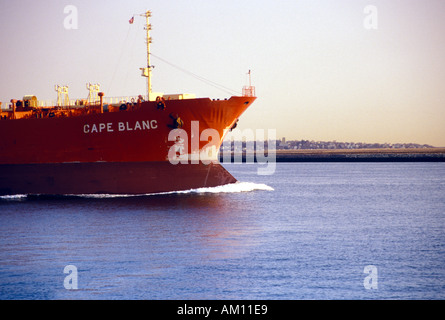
[0, 11, 256, 195]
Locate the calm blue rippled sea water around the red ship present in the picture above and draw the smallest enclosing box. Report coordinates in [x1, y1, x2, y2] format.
[0, 163, 445, 300]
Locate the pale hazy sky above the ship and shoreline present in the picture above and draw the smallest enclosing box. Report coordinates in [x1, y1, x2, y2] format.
[0, 0, 445, 146]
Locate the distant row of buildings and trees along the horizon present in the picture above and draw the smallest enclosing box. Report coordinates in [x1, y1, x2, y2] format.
[221, 138, 434, 152]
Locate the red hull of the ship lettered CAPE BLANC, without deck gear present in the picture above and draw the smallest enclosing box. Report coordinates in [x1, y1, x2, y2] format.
[0, 97, 255, 195]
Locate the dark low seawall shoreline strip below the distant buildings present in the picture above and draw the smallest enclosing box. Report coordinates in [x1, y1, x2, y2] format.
[220, 148, 445, 163]
